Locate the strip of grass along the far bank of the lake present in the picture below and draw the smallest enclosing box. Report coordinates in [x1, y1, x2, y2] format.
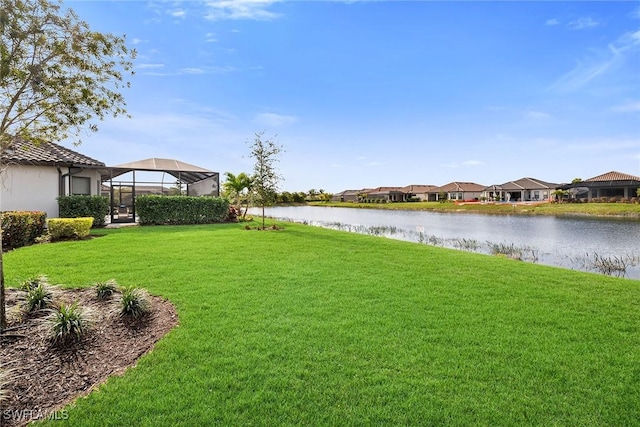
[309, 202, 640, 219]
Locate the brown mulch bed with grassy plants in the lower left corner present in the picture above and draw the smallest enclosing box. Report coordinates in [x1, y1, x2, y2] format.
[0, 288, 178, 427]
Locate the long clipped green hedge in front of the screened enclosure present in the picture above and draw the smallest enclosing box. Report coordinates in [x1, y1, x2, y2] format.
[136, 195, 229, 225]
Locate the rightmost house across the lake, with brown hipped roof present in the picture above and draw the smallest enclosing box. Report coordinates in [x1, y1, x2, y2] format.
[561, 171, 640, 201]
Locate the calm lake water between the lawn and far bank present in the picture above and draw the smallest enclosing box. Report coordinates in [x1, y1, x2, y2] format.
[249, 206, 640, 279]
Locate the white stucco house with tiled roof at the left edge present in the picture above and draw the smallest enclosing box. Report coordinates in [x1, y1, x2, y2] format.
[0, 140, 105, 218]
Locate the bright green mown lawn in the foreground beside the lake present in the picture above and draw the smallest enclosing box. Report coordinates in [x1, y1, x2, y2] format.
[5, 224, 640, 426]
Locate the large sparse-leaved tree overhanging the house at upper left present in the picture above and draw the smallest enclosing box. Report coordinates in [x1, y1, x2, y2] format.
[0, 0, 136, 331]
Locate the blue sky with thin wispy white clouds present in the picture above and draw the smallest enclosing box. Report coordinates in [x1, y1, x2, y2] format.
[65, 0, 640, 192]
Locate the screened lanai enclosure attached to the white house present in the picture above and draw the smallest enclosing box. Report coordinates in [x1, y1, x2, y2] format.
[101, 158, 220, 223]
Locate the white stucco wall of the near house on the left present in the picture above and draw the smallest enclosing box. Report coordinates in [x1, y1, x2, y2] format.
[0, 165, 100, 218]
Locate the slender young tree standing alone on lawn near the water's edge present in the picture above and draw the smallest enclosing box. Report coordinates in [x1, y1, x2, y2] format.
[248, 132, 283, 230]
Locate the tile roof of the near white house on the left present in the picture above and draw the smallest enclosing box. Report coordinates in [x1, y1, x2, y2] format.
[2, 140, 105, 167]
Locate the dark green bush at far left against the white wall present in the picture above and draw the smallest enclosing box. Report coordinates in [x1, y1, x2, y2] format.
[0, 211, 47, 251]
